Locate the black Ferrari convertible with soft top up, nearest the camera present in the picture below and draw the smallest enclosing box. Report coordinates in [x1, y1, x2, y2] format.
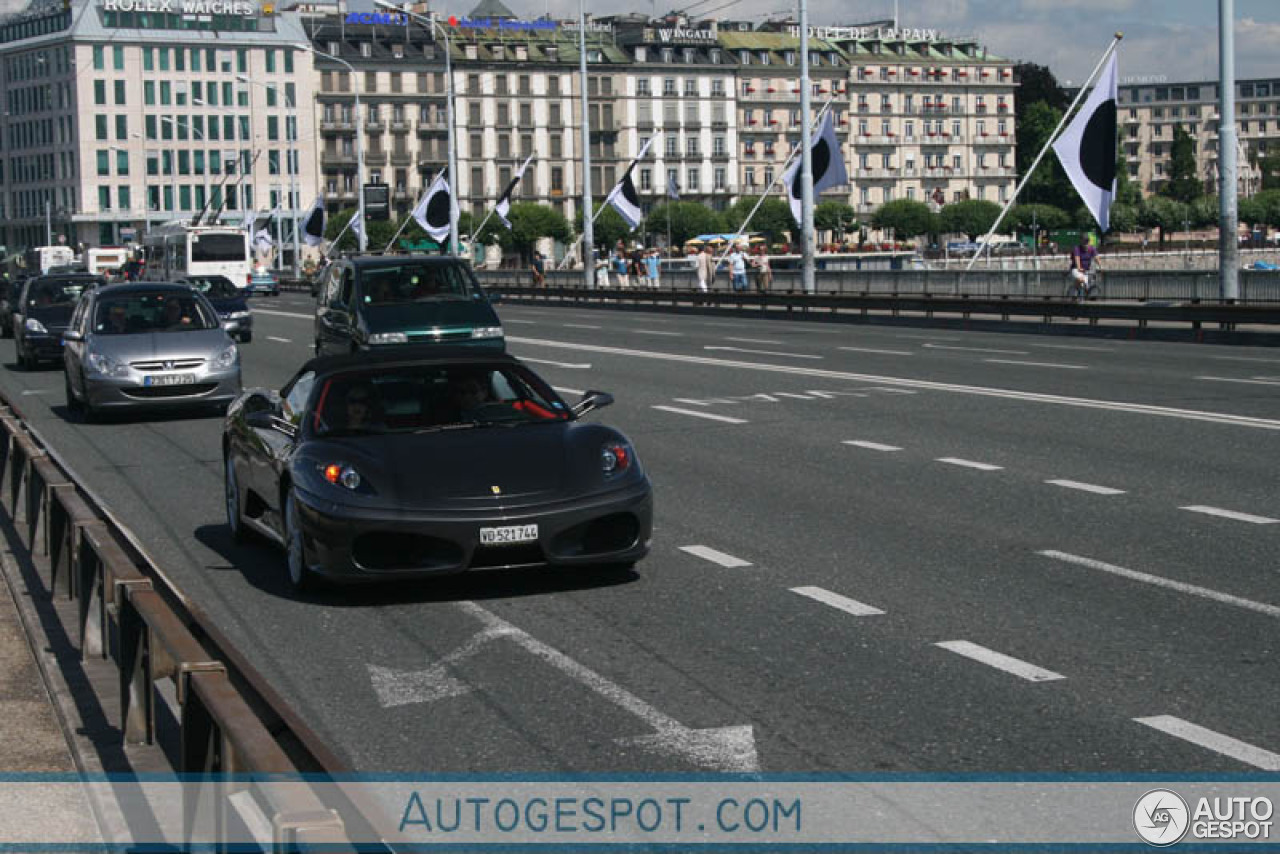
[223, 346, 653, 589]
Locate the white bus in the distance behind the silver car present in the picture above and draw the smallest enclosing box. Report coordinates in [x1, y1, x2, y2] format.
[142, 223, 253, 288]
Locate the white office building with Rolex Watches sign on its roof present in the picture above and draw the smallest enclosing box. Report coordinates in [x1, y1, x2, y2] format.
[0, 0, 316, 248]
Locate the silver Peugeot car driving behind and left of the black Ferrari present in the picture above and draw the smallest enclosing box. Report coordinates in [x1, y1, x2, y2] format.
[63, 282, 241, 420]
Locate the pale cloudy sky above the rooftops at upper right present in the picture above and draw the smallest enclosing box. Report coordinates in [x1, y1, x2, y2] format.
[494, 0, 1280, 85]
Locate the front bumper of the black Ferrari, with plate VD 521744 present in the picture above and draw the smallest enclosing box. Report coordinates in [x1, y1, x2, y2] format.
[297, 480, 653, 581]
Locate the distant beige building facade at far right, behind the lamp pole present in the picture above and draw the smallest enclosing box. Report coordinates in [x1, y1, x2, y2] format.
[1117, 79, 1280, 196]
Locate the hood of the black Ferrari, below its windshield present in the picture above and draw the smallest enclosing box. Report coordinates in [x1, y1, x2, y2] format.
[302, 424, 586, 511]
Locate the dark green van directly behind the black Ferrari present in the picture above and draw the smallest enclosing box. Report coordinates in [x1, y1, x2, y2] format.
[315, 255, 506, 356]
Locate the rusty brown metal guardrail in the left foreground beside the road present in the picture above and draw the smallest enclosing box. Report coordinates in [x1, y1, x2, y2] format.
[0, 397, 349, 850]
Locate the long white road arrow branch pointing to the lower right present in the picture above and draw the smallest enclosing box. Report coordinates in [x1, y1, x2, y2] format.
[458, 602, 760, 772]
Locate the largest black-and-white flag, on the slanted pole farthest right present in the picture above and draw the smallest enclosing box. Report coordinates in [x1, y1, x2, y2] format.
[1053, 54, 1116, 232]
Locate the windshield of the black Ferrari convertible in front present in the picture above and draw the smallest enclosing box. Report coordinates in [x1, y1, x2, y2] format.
[312, 365, 570, 435]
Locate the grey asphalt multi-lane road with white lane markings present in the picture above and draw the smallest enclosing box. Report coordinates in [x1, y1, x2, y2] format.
[0, 294, 1280, 773]
